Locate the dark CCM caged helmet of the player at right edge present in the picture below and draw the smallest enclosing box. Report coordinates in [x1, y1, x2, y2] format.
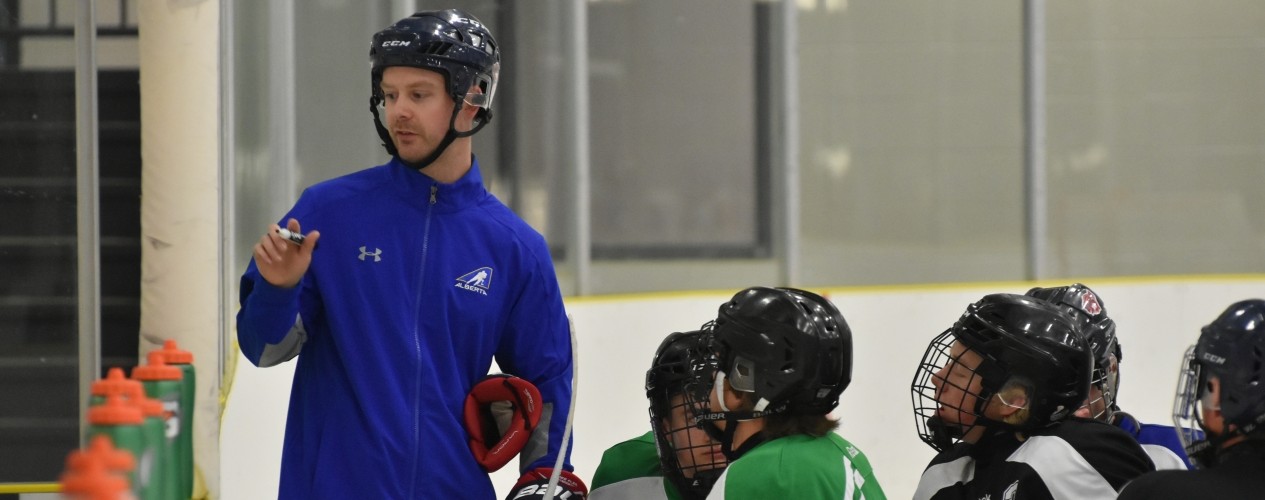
[1173, 299, 1265, 466]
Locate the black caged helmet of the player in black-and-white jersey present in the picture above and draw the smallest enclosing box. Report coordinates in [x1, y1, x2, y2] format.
[911, 294, 1093, 451]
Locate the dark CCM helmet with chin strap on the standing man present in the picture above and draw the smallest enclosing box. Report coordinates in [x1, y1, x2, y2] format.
[369, 9, 501, 168]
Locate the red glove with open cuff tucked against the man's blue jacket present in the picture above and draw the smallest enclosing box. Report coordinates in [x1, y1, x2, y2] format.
[462, 373, 541, 472]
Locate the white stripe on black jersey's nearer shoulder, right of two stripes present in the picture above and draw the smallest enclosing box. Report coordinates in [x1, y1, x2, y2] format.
[1006, 435, 1116, 500]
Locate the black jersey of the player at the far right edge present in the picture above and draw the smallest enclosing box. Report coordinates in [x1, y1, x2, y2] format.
[1120, 441, 1265, 500]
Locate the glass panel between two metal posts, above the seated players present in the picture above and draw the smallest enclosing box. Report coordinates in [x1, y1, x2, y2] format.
[799, 0, 1023, 286]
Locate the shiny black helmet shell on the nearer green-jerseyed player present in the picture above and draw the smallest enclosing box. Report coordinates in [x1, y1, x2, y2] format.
[713, 286, 853, 415]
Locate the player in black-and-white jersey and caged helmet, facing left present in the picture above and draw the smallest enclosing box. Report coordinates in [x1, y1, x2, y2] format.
[912, 294, 1154, 500]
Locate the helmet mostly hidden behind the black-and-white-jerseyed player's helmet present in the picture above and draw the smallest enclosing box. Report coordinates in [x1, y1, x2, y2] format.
[1026, 284, 1123, 422]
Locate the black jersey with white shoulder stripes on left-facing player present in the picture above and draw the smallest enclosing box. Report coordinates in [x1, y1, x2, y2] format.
[913, 419, 1155, 500]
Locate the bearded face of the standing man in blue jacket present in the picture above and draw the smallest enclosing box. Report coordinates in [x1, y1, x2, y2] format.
[382, 66, 465, 162]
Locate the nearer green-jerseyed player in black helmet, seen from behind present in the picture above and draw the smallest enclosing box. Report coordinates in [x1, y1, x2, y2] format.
[689, 287, 886, 500]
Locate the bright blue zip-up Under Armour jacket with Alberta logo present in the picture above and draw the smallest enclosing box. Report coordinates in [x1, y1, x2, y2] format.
[238, 158, 572, 499]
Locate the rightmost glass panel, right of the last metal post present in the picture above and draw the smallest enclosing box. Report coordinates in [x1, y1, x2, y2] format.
[1046, 0, 1265, 276]
